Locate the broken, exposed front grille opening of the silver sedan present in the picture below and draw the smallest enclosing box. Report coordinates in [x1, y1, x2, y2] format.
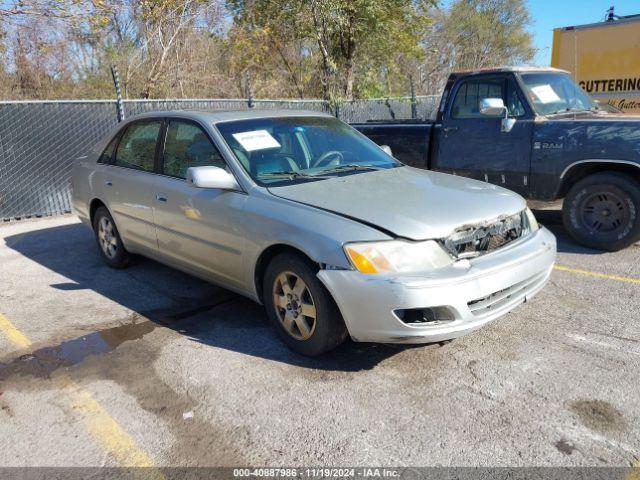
[441, 212, 528, 258]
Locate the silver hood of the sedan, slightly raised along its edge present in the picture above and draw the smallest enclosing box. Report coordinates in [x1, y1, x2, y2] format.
[269, 167, 526, 240]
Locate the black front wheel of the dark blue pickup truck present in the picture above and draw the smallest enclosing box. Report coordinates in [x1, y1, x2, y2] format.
[562, 172, 640, 252]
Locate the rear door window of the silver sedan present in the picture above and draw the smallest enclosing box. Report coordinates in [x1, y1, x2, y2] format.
[114, 120, 162, 172]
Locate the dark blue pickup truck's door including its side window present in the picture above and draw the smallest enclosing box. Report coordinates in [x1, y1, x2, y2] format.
[432, 66, 535, 196]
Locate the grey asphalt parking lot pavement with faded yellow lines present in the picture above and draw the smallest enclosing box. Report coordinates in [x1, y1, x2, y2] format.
[0, 211, 640, 467]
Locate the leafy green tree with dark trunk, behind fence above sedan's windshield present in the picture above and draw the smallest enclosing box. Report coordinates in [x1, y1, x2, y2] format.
[229, 0, 434, 99]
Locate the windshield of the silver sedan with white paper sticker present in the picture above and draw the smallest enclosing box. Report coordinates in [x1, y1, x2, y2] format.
[216, 117, 402, 185]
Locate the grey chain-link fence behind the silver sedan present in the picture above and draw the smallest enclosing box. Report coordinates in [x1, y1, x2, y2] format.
[0, 96, 438, 221]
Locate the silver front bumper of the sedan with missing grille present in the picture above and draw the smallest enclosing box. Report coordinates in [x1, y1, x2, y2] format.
[318, 228, 556, 343]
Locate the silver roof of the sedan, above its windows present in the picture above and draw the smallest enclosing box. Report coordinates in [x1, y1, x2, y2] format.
[127, 109, 332, 124]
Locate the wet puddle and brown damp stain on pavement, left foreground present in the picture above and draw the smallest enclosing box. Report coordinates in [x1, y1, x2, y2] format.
[0, 296, 249, 466]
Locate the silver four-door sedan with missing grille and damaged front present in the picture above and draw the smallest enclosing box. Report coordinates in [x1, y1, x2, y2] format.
[72, 111, 556, 355]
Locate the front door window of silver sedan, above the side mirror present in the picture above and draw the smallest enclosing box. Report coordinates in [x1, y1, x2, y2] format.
[162, 120, 226, 178]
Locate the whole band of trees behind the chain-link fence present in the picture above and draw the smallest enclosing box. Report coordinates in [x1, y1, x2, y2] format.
[0, 0, 534, 101]
